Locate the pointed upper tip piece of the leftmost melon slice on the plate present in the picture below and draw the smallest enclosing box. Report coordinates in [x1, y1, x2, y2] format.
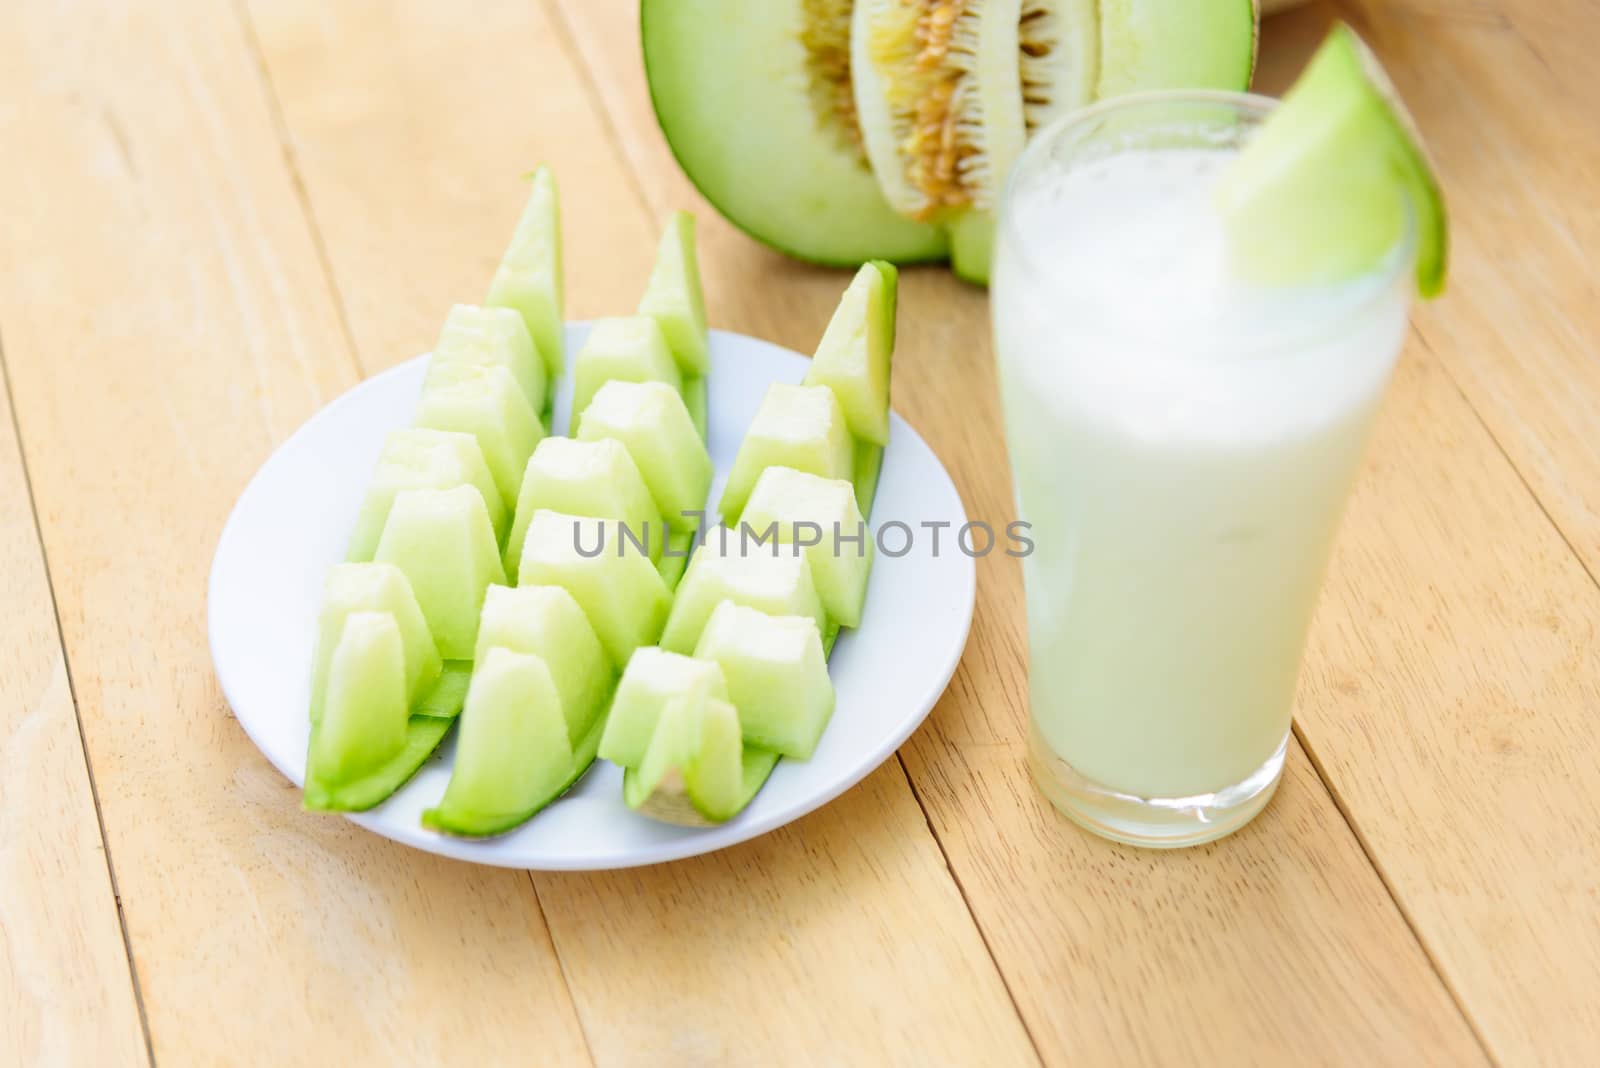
[485, 166, 566, 381]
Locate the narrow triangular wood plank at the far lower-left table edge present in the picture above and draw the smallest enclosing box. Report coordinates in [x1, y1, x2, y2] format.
[0, 356, 147, 1065]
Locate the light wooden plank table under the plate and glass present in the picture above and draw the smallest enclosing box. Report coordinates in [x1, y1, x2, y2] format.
[0, 0, 1600, 1065]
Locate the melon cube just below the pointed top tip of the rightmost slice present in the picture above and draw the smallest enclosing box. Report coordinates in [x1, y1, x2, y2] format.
[718, 382, 854, 523]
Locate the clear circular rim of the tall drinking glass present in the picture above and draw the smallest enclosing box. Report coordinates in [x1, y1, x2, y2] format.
[998, 90, 1418, 357]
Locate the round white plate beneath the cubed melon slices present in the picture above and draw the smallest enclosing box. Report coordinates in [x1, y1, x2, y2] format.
[208, 323, 974, 870]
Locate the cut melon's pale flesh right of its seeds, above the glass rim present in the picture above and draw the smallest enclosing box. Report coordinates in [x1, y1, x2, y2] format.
[1094, 0, 1256, 101]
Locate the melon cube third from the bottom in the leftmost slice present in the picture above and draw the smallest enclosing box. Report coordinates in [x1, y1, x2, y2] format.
[376, 486, 506, 660]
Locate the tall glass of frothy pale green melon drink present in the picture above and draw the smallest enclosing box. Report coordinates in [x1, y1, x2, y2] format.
[992, 93, 1416, 846]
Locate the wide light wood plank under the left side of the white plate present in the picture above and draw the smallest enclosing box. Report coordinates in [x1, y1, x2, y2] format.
[0, 2, 586, 1065]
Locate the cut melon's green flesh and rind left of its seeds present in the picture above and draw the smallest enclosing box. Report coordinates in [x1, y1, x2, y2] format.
[640, 0, 946, 267]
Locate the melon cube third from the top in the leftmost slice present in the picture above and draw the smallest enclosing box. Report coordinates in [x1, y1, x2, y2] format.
[416, 363, 544, 508]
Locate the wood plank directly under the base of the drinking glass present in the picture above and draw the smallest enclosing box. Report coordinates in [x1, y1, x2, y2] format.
[558, 0, 1483, 1063]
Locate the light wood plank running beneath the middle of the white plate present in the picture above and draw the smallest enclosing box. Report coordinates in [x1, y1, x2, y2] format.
[238, 0, 1034, 1063]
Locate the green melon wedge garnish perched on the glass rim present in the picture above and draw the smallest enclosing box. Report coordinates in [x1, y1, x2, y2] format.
[1216, 26, 1450, 297]
